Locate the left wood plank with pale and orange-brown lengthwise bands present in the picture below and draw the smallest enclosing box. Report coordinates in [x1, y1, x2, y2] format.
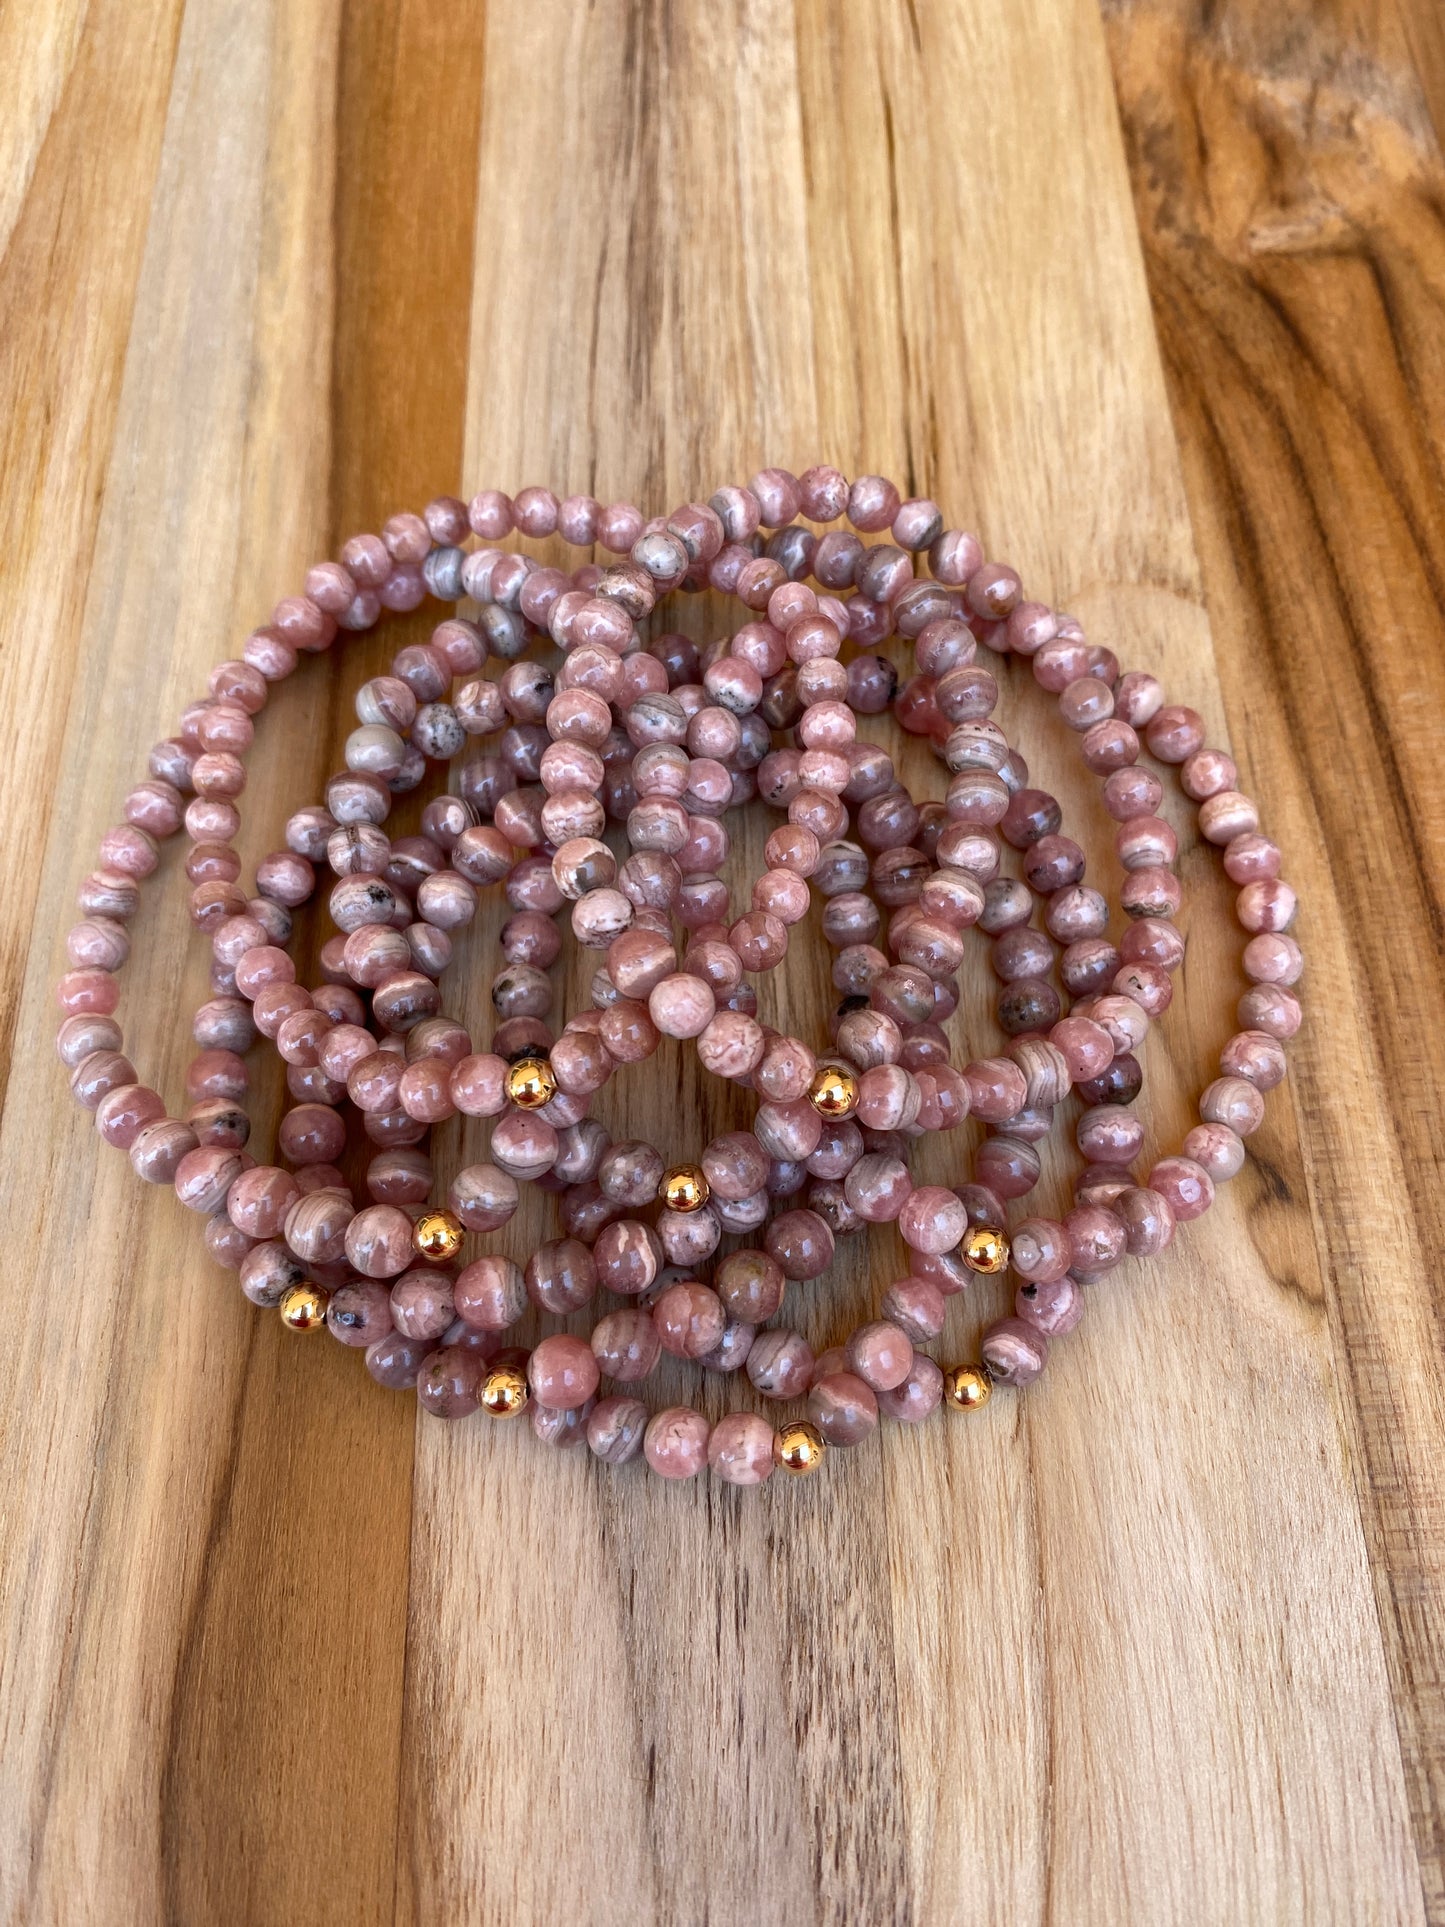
[0, 4, 480, 1921]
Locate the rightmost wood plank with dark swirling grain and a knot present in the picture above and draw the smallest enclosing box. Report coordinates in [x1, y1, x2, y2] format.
[1106, 4, 1445, 1917]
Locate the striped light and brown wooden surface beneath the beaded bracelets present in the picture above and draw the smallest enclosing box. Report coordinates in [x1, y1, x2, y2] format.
[0, 0, 1445, 1927]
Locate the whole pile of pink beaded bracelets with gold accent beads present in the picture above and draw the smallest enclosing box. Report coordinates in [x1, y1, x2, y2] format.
[58, 466, 1302, 1486]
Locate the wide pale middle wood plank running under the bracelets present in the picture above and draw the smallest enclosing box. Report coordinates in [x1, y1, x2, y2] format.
[393, 6, 1420, 1919]
